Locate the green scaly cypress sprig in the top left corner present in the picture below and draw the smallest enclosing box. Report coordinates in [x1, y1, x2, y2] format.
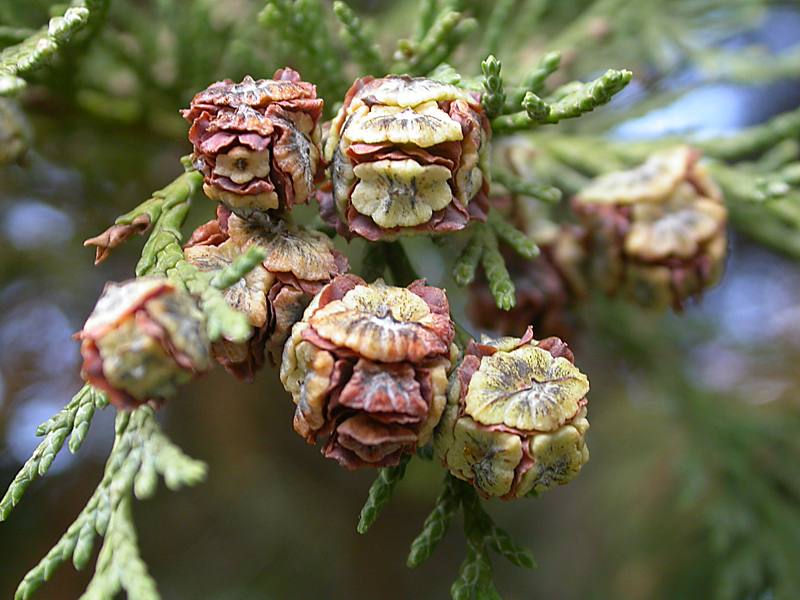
[0, 0, 110, 96]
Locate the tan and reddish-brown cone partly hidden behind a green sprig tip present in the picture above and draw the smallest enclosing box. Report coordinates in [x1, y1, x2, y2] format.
[189, 210, 349, 380]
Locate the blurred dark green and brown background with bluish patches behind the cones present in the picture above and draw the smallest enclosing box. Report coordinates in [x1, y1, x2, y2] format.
[0, 0, 800, 600]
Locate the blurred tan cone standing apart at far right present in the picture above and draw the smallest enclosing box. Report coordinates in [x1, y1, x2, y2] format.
[573, 146, 727, 308]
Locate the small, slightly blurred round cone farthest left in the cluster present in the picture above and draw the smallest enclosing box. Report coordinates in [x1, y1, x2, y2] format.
[77, 277, 211, 408]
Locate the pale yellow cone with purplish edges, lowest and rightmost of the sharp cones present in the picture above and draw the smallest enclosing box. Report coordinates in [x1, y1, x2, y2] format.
[434, 328, 589, 499]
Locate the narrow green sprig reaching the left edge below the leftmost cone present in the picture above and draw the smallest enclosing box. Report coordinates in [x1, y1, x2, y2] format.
[0, 384, 108, 521]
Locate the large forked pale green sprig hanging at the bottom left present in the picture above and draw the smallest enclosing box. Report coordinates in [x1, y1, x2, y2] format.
[14, 405, 206, 600]
